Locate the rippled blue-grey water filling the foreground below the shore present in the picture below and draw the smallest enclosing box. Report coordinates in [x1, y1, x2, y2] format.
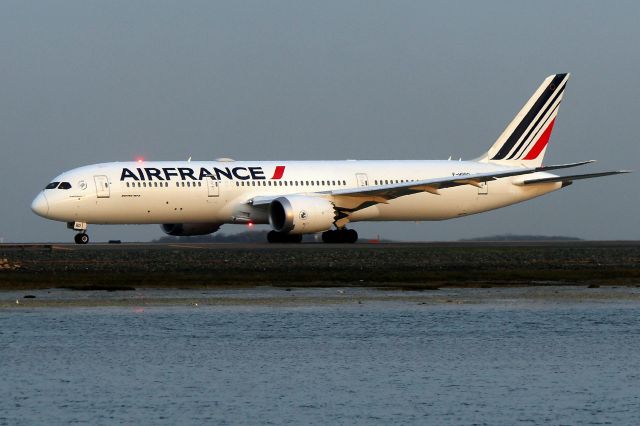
[0, 290, 640, 425]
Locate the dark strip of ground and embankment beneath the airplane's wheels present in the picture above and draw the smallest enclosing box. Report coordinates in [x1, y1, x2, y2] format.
[0, 241, 640, 290]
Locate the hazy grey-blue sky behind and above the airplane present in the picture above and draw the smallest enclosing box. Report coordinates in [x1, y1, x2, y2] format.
[0, 0, 640, 242]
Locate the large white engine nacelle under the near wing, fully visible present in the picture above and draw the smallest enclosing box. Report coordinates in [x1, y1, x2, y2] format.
[269, 195, 336, 234]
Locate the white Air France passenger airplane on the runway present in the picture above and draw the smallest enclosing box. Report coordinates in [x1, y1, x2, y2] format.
[31, 73, 629, 244]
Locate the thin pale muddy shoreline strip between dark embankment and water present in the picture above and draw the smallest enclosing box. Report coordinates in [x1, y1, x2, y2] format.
[0, 286, 640, 311]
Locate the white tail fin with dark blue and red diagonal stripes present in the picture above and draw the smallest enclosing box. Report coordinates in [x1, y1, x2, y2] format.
[477, 73, 570, 167]
